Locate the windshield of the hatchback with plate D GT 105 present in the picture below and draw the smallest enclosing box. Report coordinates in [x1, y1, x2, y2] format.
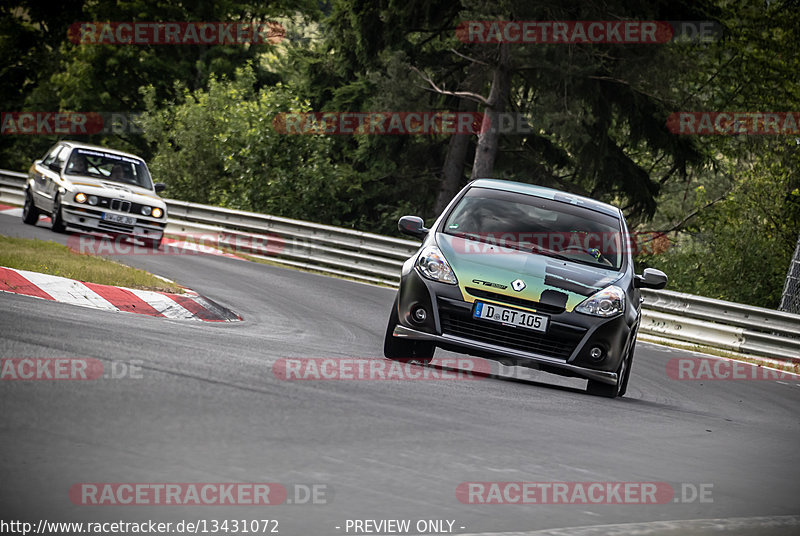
[442, 188, 626, 270]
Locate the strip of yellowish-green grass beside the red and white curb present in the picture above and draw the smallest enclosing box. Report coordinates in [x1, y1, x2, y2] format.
[0, 236, 183, 294]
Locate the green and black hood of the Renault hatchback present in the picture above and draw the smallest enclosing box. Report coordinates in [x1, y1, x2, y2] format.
[436, 233, 623, 311]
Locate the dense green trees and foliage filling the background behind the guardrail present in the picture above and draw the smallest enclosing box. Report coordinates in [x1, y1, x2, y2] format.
[0, 0, 800, 307]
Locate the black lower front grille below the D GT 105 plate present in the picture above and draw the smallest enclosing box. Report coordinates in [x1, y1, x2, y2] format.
[439, 307, 586, 360]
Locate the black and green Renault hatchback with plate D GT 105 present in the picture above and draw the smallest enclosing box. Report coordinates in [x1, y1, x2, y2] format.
[384, 179, 667, 397]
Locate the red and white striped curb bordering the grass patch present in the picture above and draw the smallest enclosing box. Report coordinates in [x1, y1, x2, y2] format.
[0, 267, 242, 322]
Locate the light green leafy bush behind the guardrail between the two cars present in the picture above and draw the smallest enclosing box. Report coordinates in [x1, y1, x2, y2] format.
[143, 67, 354, 224]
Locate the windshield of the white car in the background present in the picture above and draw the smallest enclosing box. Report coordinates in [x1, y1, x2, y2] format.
[64, 149, 153, 190]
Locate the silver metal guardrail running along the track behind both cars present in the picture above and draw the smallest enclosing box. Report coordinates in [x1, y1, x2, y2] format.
[0, 170, 800, 363]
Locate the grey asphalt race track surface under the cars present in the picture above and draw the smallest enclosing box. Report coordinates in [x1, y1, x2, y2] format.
[0, 210, 800, 536]
